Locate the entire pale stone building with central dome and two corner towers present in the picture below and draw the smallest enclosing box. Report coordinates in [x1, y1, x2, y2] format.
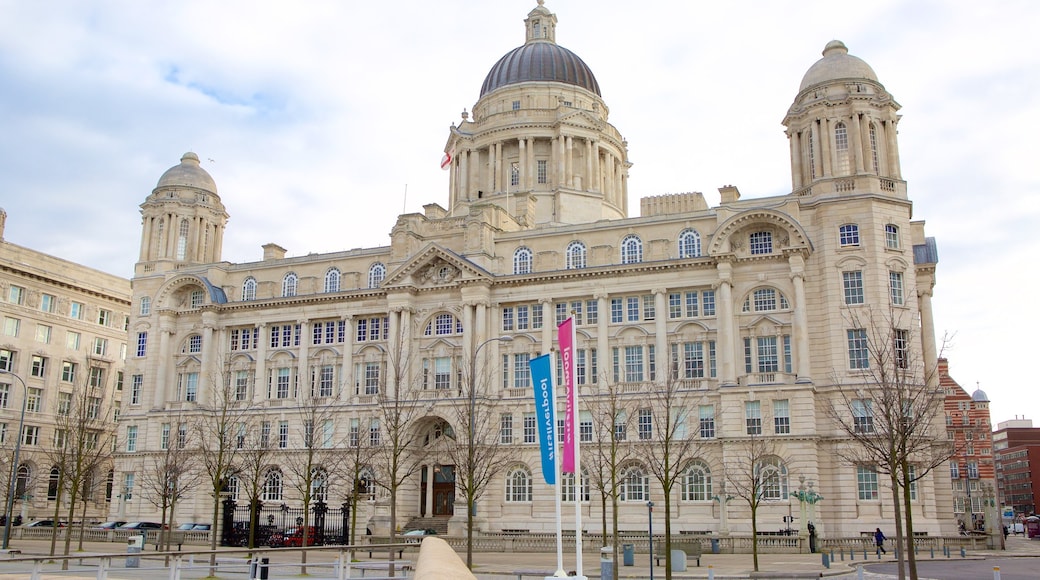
[113, 2, 955, 535]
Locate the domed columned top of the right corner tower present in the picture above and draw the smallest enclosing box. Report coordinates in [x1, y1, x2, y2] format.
[783, 41, 906, 197]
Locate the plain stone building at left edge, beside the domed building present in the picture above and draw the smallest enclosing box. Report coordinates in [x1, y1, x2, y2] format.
[0, 209, 130, 528]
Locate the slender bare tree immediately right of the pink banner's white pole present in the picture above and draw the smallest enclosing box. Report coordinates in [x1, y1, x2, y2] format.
[581, 377, 633, 580]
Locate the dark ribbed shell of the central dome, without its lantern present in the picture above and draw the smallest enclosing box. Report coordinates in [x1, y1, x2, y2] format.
[480, 41, 602, 97]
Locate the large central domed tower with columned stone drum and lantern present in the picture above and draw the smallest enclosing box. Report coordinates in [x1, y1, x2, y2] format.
[445, 0, 630, 228]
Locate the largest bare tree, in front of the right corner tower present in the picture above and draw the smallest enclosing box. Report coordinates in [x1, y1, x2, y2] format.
[828, 309, 954, 580]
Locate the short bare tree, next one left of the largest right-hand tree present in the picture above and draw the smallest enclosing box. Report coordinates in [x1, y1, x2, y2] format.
[724, 423, 787, 572]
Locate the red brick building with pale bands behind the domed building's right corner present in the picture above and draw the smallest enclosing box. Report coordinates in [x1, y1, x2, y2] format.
[938, 359, 994, 529]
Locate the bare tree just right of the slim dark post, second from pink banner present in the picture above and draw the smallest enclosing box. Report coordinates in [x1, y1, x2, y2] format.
[636, 367, 701, 580]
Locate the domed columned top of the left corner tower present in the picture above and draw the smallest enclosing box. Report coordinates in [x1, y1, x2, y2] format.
[138, 152, 228, 273]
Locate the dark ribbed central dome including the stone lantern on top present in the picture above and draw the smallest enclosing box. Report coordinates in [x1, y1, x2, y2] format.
[480, 0, 602, 99]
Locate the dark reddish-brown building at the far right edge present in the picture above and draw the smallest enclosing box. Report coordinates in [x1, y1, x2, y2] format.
[993, 419, 1040, 518]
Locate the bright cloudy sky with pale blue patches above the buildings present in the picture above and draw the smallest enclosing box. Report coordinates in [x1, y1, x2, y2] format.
[0, 0, 1040, 426]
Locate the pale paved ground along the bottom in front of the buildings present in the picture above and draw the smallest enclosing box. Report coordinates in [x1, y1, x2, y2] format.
[0, 536, 1040, 580]
